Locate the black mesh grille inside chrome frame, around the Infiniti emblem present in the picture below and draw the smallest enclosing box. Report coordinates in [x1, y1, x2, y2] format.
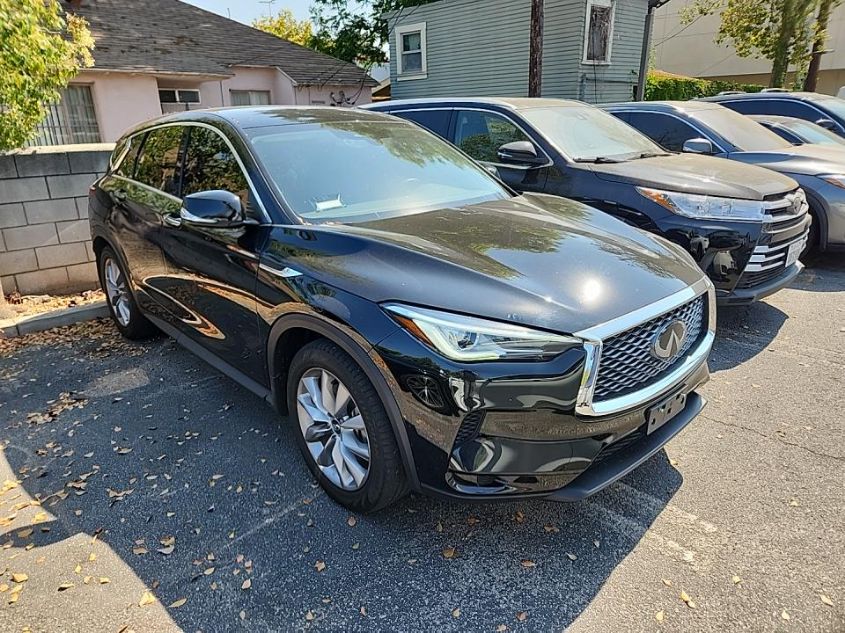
[593, 294, 708, 402]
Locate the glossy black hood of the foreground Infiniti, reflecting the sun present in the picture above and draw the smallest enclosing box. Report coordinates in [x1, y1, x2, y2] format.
[271, 195, 703, 333]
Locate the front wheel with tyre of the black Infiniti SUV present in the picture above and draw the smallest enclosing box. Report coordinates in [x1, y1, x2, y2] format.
[287, 340, 408, 512]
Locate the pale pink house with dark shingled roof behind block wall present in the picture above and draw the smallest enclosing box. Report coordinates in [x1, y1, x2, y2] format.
[36, 0, 376, 145]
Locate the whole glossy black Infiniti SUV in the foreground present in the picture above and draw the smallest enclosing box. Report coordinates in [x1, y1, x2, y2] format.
[89, 107, 716, 511]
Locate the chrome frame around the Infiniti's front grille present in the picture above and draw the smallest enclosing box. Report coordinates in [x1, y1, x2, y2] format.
[573, 277, 716, 417]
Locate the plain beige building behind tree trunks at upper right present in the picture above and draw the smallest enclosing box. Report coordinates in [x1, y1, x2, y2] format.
[652, 0, 845, 95]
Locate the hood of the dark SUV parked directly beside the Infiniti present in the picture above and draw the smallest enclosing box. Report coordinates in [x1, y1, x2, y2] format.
[590, 154, 798, 200]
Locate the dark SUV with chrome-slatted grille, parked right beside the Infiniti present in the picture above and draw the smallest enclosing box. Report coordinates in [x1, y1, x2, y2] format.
[365, 98, 810, 304]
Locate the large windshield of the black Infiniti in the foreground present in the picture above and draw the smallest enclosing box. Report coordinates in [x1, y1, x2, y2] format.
[248, 120, 511, 223]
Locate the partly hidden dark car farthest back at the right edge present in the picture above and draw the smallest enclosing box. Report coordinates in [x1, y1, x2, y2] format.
[702, 92, 845, 136]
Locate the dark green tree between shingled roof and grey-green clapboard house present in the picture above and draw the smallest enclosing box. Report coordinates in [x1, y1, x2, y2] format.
[311, 0, 433, 68]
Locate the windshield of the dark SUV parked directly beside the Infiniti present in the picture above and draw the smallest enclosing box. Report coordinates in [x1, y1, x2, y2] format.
[520, 105, 666, 161]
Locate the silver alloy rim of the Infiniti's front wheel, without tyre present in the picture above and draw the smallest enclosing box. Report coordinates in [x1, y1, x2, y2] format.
[296, 367, 370, 490]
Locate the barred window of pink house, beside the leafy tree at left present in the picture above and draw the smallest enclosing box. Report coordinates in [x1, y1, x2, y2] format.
[27, 85, 100, 146]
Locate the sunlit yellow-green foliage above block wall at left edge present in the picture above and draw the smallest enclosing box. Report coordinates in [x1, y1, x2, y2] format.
[0, 0, 94, 151]
